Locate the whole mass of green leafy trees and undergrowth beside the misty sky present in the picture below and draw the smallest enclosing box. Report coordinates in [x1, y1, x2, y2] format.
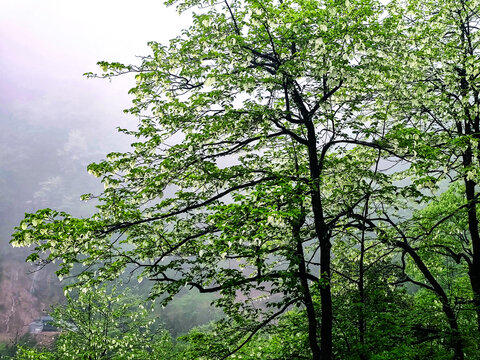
[5, 0, 480, 360]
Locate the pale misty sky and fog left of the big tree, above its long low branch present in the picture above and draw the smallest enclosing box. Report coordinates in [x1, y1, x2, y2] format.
[0, 0, 190, 239]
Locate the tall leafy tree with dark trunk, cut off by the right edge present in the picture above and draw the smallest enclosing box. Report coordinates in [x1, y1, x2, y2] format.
[388, 0, 480, 331]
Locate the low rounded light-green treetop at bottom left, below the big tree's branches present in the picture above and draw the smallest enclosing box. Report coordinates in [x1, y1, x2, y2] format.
[48, 286, 173, 360]
